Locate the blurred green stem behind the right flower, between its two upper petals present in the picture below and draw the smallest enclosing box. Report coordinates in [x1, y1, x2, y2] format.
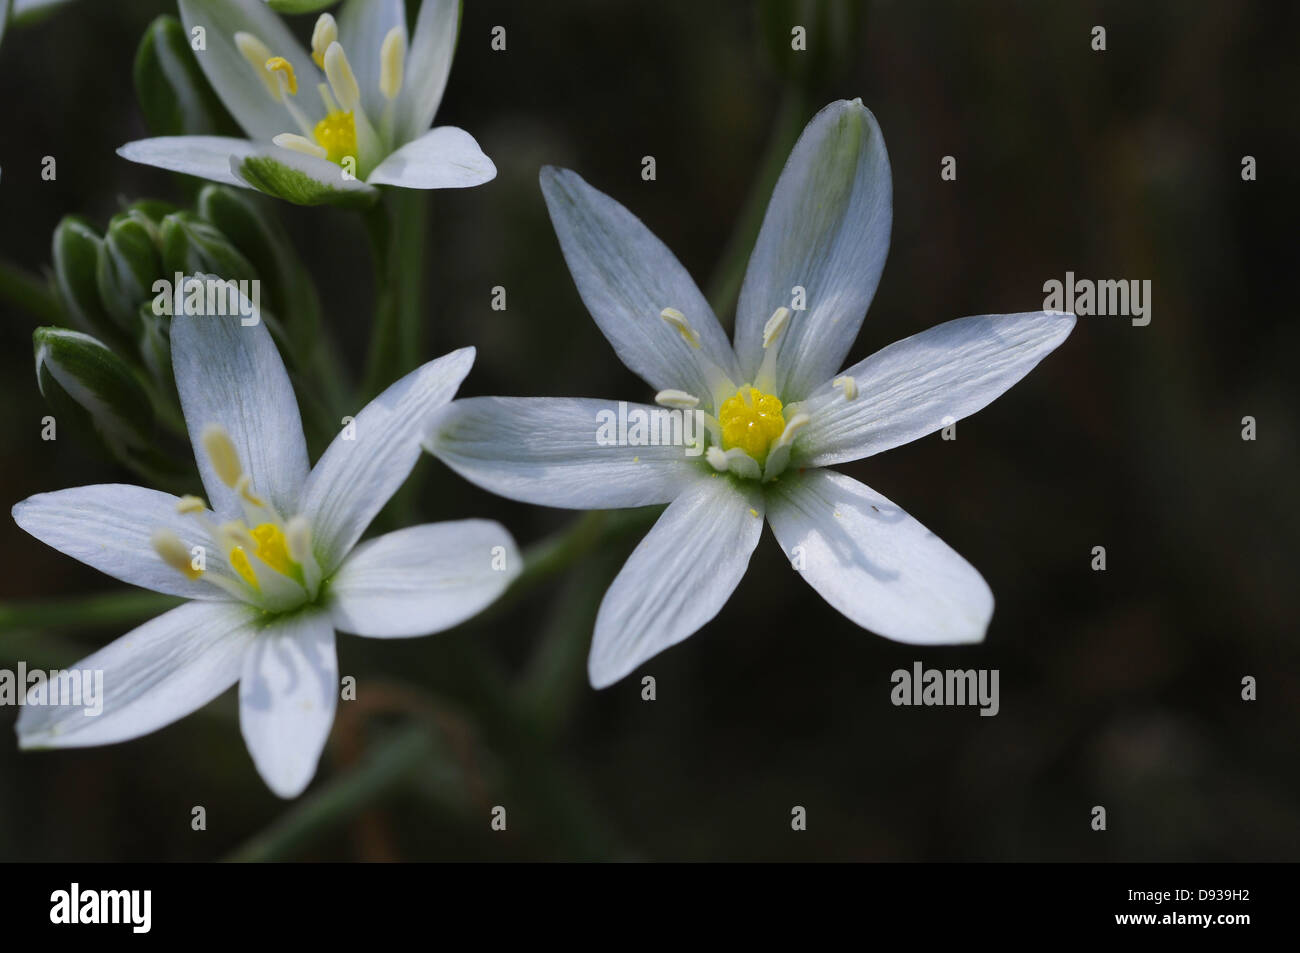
[706, 86, 809, 315]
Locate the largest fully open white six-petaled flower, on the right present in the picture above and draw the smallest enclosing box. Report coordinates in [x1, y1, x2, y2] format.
[425, 100, 1075, 688]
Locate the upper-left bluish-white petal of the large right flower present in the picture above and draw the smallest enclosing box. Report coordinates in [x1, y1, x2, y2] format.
[541, 166, 741, 403]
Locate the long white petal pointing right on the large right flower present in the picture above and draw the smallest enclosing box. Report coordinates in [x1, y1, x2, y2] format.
[794, 311, 1075, 467]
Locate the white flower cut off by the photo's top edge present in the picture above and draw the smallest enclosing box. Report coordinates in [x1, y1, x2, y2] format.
[118, 0, 497, 204]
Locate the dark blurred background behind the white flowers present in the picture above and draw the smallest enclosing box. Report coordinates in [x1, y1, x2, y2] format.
[0, 0, 1300, 861]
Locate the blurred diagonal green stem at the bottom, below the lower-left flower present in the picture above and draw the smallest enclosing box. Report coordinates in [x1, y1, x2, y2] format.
[225, 724, 436, 863]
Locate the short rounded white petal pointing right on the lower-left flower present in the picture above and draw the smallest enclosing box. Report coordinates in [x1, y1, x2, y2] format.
[329, 520, 523, 638]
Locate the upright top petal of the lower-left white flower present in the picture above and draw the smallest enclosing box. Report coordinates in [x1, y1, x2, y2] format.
[172, 298, 308, 519]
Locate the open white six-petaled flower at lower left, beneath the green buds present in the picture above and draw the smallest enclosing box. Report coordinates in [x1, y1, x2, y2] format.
[13, 291, 520, 797]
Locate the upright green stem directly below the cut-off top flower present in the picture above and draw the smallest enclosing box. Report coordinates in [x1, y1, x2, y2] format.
[361, 189, 429, 400]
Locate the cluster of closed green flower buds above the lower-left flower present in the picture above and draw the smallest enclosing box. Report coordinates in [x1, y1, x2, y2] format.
[34, 185, 315, 478]
